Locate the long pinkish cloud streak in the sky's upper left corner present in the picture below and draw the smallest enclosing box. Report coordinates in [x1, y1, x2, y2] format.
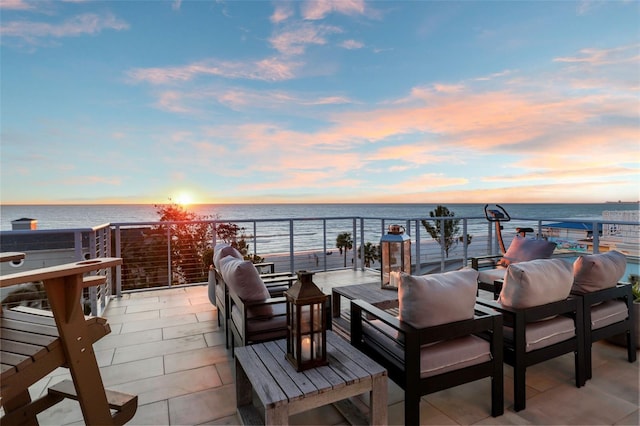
[0, 13, 129, 43]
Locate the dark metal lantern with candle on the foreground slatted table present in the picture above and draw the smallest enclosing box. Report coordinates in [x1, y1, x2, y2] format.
[284, 271, 329, 371]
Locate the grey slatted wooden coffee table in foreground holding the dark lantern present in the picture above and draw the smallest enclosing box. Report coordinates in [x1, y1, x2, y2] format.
[235, 331, 388, 425]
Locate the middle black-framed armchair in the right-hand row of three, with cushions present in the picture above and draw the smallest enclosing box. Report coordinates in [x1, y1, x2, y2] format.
[478, 259, 586, 411]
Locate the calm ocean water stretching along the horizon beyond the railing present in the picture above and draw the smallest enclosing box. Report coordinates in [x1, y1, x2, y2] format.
[0, 203, 640, 231]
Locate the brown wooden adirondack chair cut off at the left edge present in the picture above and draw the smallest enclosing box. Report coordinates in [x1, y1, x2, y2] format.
[0, 253, 138, 425]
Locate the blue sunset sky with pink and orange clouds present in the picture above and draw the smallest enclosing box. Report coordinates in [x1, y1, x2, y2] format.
[0, 0, 640, 204]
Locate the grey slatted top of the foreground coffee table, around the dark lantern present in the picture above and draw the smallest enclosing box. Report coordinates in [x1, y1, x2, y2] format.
[235, 331, 386, 407]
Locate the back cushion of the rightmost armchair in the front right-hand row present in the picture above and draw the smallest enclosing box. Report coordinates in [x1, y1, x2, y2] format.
[573, 250, 627, 293]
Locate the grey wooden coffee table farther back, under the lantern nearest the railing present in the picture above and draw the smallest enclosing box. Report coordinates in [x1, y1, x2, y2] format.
[331, 282, 398, 338]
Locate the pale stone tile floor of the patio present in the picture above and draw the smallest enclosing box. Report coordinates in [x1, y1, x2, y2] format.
[25, 271, 639, 425]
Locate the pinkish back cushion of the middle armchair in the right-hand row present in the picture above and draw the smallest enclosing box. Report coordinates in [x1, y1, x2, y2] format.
[498, 259, 573, 309]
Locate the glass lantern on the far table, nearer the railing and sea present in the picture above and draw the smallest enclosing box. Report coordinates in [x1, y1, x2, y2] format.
[380, 225, 411, 290]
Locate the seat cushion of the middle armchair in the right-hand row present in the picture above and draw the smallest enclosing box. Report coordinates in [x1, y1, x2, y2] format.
[504, 316, 576, 352]
